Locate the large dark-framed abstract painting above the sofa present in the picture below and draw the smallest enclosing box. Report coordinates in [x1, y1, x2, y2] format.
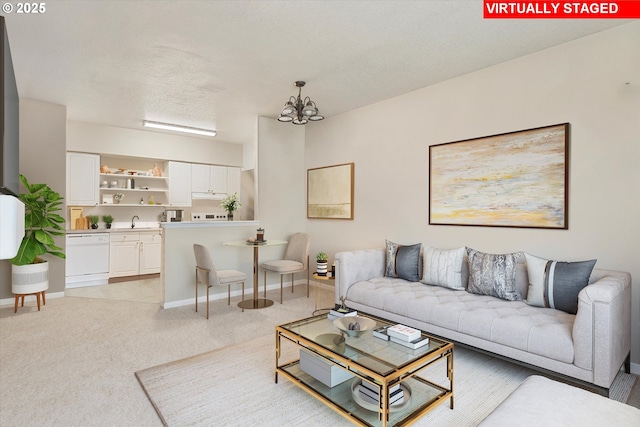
[429, 123, 570, 230]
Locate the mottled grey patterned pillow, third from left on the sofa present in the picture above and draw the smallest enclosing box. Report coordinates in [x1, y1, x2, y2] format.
[467, 248, 522, 301]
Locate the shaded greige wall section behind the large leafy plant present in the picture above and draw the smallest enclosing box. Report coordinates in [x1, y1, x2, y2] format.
[0, 99, 67, 298]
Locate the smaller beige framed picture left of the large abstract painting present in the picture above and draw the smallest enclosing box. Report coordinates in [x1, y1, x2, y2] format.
[307, 162, 355, 220]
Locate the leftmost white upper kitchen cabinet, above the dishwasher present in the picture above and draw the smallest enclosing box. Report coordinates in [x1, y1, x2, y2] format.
[66, 152, 100, 206]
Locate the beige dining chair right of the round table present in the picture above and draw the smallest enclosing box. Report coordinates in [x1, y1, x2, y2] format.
[262, 233, 311, 304]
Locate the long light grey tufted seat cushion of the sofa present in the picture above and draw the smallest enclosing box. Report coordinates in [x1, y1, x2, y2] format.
[347, 277, 575, 363]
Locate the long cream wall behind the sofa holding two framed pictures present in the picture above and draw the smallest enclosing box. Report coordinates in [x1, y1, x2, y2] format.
[304, 22, 640, 364]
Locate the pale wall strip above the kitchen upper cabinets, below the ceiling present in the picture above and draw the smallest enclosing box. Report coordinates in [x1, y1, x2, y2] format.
[67, 121, 243, 167]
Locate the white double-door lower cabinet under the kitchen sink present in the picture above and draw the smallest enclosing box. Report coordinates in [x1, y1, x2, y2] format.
[109, 230, 162, 277]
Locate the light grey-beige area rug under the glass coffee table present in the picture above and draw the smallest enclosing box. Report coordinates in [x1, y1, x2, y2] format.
[136, 335, 635, 427]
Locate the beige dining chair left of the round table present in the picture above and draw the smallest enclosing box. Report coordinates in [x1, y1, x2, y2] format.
[193, 243, 247, 319]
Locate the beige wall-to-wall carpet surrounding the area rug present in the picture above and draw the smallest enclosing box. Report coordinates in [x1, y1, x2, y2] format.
[0, 282, 640, 427]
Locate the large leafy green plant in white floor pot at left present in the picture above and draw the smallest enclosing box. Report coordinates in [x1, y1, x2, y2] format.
[10, 175, 65, 302]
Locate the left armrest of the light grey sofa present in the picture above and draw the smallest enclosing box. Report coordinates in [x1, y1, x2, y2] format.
[335, 248, 385, 304]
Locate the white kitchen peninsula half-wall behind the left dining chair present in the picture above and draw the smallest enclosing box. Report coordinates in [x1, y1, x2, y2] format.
[162, 221, 286, 308]
